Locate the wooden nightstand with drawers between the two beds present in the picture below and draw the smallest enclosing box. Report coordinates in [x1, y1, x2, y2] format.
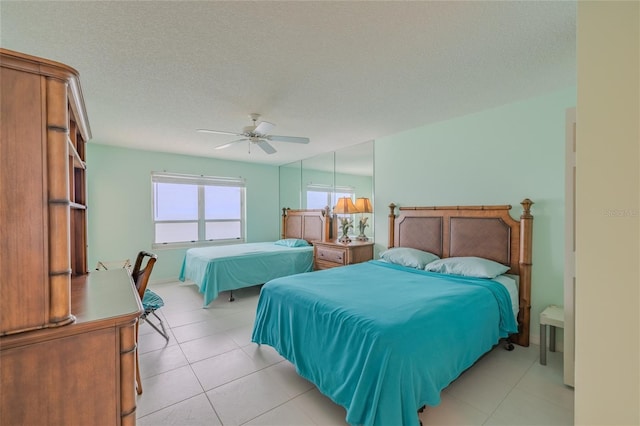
[313, 240, 373, 270]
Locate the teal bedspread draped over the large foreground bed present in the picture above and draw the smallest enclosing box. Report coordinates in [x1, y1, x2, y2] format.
[252, 261, 517, 426]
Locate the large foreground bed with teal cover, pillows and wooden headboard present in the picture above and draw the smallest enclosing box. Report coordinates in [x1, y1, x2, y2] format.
[252, 199, 533, 425]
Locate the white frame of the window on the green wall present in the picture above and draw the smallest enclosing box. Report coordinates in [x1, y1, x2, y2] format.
[151, 172, 246, 249]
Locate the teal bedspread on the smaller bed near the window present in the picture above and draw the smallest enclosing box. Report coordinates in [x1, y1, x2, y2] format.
[179, 242, 313, 306]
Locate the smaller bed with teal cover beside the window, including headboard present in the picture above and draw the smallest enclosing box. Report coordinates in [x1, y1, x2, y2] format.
[179, 209, 332, 306]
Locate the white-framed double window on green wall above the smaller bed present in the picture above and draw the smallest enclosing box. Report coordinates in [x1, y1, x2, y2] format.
[151, 172, 245, 248]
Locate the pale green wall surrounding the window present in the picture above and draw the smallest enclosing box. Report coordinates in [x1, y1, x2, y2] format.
[87, 143, 281, 281]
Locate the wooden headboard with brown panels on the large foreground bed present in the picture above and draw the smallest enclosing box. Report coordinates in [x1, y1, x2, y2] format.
[389, 198, 533, 346]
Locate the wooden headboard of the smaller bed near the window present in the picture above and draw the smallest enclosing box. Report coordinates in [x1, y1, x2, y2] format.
[282, 208, 331, 243]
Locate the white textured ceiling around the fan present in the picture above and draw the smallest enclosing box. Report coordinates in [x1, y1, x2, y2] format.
[0, 0, 576, 165]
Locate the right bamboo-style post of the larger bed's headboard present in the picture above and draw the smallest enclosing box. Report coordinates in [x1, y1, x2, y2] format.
[516, 198, 533, 346]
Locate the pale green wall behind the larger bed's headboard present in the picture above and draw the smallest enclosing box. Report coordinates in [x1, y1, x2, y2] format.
[374, 87, 576, 343]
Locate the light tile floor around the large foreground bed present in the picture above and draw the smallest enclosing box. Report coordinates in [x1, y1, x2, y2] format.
[137, 283, 573, 426]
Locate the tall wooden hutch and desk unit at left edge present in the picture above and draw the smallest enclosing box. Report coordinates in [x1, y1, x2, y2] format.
[0, 49, 141, 425]
